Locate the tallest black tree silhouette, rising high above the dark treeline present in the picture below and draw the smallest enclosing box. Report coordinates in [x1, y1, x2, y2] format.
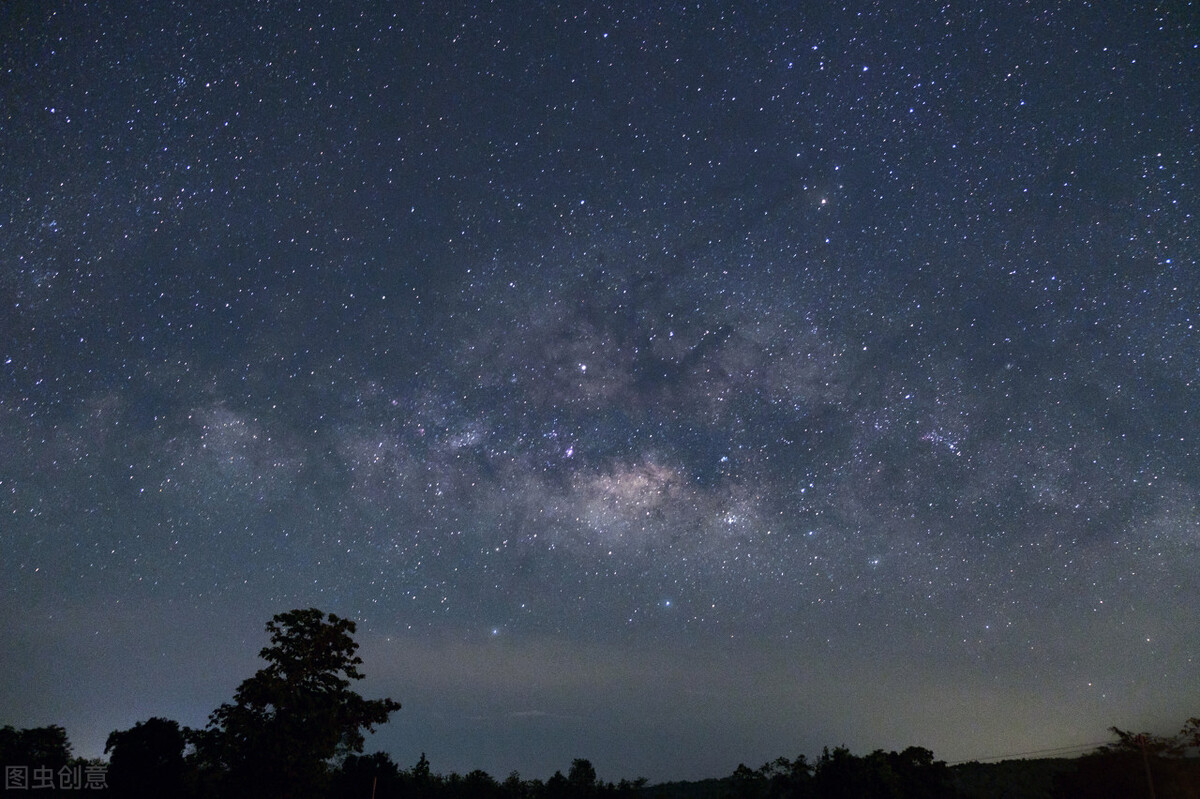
[196, 608, 400, 798]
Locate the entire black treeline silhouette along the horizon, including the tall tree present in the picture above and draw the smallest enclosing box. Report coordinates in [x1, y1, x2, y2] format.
[7, 608, 1200, 799]
